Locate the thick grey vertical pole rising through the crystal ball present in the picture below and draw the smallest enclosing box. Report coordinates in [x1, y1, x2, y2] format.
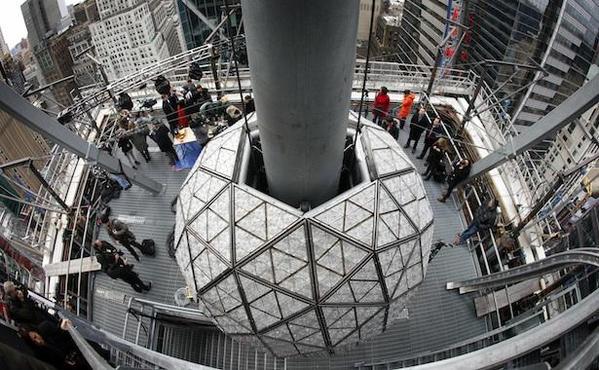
[241, 0, 359, 207]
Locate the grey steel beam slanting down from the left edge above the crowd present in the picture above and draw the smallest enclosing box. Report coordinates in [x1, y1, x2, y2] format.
[0, 83, 162, 194]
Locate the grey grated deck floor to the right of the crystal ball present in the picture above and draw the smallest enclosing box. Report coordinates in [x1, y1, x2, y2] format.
[287, 125, 486, 369]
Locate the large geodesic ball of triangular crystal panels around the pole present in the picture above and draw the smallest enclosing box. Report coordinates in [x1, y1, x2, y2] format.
[175, 117, 433, 356]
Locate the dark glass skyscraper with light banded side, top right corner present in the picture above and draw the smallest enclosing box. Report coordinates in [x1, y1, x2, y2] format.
[463, 0, 599, 126]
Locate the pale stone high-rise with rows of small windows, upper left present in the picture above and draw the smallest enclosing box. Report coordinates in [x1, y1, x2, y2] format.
[90, 0, 181, 80]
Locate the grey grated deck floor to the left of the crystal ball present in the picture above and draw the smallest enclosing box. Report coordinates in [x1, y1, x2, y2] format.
[92, 140, 189, 339]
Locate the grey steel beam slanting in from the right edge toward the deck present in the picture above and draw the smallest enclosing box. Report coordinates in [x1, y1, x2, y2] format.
[470, 75, 599, 179]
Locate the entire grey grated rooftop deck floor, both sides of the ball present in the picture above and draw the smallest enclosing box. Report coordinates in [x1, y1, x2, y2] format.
[92, 120, 486, 368]
